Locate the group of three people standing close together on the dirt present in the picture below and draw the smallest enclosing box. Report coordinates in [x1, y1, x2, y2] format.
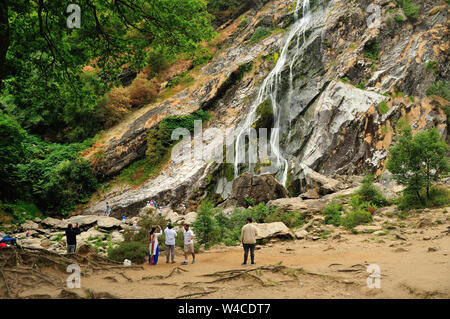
[148, 224, 195, 265]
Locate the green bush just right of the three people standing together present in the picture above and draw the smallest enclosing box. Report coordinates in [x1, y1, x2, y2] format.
[192, 201, 220, 249]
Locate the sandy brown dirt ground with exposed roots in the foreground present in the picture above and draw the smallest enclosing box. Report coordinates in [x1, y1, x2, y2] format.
[20, 218, 450, 299]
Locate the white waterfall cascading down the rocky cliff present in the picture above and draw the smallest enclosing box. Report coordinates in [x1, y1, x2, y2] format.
[234, 0, 311, 185]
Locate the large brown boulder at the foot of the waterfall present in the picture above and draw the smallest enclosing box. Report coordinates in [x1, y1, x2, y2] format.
[223, 173, 289, 207]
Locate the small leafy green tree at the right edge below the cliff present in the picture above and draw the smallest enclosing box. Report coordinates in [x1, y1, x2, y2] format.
[386, 127, 449, 203]
